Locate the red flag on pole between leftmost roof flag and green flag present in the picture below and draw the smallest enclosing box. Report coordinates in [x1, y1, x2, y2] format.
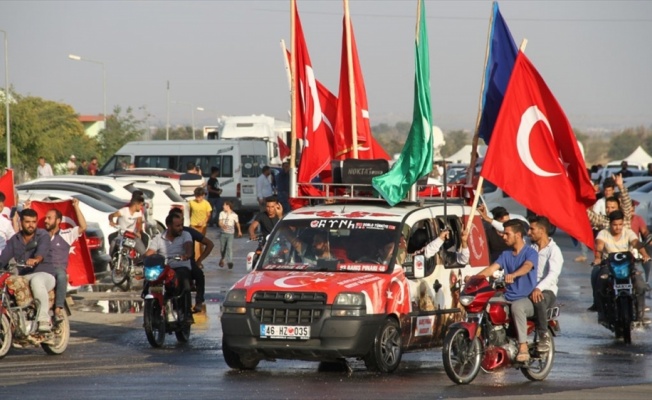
[333, 19, 390, 160]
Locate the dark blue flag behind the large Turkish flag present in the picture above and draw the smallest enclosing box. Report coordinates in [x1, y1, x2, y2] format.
[478, 2, 518, 144]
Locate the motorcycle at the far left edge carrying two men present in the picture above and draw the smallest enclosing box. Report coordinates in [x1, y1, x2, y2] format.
[0, 265, 70, 358]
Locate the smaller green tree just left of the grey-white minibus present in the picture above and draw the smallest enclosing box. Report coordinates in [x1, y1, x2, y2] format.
[97, 106, 148, 163]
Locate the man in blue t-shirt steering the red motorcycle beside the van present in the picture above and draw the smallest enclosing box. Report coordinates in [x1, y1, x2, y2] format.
[478, 219, 539, 362]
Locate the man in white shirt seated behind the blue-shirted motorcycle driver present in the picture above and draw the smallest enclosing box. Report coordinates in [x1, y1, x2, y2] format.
[528, 215, 564, 353]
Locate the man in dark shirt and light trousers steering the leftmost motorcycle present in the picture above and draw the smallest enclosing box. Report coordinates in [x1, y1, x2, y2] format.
[0, 209, 55, 333]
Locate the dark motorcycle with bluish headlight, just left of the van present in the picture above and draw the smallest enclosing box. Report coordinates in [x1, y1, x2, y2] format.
[142, 255, 192, 347]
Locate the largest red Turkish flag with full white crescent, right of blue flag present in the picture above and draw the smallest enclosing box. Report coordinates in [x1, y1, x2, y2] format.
[480, 52, 595, 248]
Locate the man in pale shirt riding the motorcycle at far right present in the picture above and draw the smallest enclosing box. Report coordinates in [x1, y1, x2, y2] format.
[592, 210, 650, 325]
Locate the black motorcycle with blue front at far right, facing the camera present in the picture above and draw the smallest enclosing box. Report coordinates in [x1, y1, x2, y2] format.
[598, 251, 644, 344]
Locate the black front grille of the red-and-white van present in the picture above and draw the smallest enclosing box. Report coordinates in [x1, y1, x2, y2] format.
[253, 292, 326, 325]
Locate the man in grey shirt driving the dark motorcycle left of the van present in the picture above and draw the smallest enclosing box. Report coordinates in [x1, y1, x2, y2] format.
[145, 213, 193, 323]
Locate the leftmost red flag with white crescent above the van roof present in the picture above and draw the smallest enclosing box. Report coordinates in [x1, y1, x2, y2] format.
[292, 4, 337, 183]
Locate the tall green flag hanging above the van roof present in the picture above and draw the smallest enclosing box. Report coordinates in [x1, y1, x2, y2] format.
[371, 0, 433, 206]
